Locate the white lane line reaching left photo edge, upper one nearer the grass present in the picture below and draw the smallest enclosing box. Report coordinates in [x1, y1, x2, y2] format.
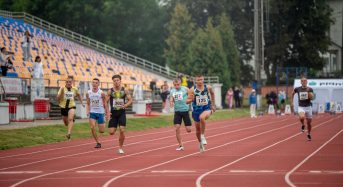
[0, 118, 253, 159]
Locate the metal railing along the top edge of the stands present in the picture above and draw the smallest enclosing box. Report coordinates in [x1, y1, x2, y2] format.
[0, 10, 219, 83]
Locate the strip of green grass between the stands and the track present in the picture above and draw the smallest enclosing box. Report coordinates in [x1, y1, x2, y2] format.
[0, 109, 249, 150]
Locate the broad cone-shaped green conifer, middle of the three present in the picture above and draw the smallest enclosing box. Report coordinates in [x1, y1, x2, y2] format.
[188, 18, 231, 90]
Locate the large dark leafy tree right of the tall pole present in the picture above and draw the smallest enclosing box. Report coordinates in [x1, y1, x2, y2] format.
[264, 0, 332, 82]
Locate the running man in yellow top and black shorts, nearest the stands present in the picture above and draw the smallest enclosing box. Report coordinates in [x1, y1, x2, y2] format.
[57, 76, 85, 140]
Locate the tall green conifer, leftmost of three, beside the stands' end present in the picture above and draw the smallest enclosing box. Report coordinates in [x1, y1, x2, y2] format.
[164, 4, 194, 73]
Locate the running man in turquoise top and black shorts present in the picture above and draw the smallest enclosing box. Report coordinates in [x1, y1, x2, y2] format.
[170, 79, 192, 151]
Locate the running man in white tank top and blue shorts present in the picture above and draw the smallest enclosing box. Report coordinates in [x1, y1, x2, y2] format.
[86, 78, 108, 148]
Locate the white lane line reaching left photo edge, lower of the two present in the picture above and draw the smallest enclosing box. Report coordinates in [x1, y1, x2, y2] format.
[0, 117, 272, 171]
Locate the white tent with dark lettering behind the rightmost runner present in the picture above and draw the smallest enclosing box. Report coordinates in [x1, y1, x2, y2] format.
[294, 79, 343, 112]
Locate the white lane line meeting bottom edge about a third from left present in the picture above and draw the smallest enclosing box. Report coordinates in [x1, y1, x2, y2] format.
[103, 118, 298, 187]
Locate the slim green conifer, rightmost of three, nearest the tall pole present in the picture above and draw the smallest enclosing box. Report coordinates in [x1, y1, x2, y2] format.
[217, 14, 241, 86]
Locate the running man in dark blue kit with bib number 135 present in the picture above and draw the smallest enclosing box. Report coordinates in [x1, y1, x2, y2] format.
[187, 75, 216, 152]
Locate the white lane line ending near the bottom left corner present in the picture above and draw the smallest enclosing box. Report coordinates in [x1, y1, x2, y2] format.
[11, 119, 288, 187]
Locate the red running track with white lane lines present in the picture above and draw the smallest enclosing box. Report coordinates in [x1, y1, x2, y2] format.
[0, 114, 343, 187]
